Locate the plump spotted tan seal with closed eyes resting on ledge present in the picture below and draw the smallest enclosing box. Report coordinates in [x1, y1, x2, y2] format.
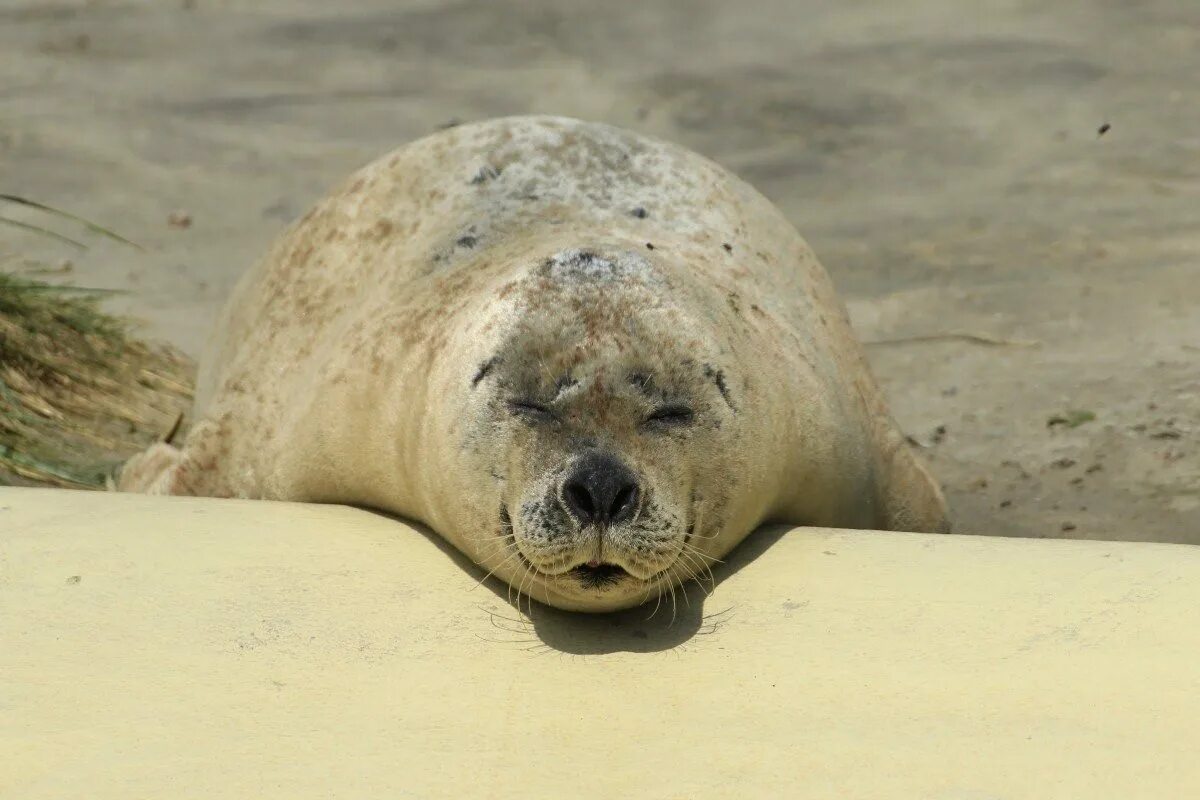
[118, 116, 948, 612]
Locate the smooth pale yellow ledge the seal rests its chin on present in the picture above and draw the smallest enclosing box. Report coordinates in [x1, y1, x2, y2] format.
[0, 489, 1200, 800]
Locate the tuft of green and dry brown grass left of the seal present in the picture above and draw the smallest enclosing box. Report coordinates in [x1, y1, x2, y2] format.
[0, 196, 193, 488]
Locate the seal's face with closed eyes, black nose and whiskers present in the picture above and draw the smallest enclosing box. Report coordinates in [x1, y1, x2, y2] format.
[461, 247, 742, 608]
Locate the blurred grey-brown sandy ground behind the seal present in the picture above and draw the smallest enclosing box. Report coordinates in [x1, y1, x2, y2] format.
[0, 0, 1200, 542]
